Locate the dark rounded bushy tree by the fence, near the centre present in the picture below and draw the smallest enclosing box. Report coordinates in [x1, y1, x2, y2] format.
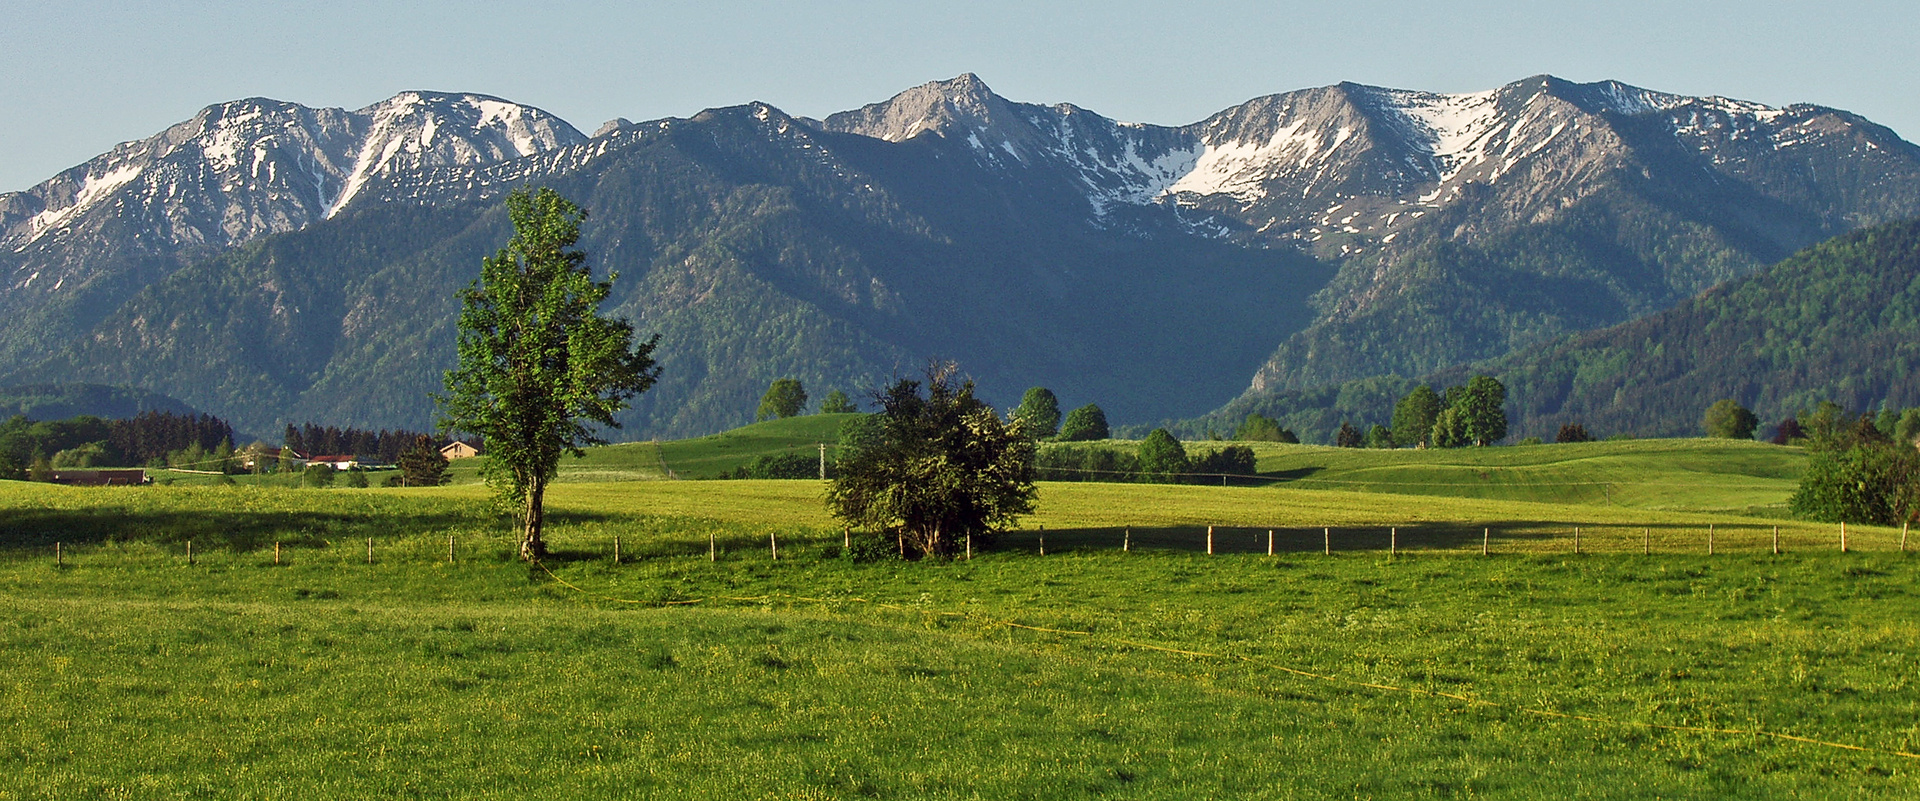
[828, 363, 1035, 557]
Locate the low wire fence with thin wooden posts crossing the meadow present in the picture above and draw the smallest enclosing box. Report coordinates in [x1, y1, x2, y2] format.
[33, 521, 1920, 567]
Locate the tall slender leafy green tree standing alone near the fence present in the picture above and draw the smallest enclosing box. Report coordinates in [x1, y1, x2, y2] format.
[434, 188, 660, 561]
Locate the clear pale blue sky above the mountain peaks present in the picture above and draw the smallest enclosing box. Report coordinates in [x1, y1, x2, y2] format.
[0, 0, 1920, 192]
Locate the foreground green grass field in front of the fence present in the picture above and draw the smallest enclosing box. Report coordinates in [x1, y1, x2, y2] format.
[0, 499, 1920, 799]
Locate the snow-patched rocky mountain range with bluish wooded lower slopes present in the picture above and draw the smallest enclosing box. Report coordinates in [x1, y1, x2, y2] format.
[0, 75, 1920, 436]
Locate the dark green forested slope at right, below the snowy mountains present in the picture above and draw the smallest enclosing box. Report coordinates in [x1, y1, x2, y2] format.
[1177, 221, 1920, 442]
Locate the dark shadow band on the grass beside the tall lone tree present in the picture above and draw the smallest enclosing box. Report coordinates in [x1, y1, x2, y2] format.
[0, 507, 611, 551]
